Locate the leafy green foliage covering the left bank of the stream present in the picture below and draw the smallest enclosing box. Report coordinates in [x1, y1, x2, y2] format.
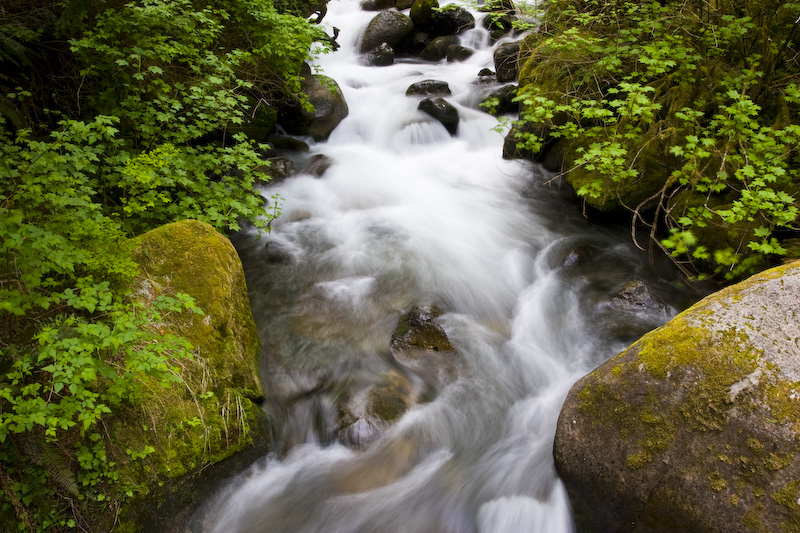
[0, 0, 323, 531]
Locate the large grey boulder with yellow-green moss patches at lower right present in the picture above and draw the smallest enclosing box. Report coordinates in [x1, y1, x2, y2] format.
[554, 262, 800, 532]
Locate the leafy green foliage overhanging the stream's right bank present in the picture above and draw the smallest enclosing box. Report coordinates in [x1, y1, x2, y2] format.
[515, 0, 800, 279]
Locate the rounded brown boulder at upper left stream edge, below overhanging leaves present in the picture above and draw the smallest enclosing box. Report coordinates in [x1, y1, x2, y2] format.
[280, 72, 349, 141]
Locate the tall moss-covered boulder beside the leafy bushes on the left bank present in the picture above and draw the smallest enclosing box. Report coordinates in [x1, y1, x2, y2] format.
[115, 220, 266, 531]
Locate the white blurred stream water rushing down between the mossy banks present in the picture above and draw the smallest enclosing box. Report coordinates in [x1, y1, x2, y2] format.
[189, 0, 692, 533]
